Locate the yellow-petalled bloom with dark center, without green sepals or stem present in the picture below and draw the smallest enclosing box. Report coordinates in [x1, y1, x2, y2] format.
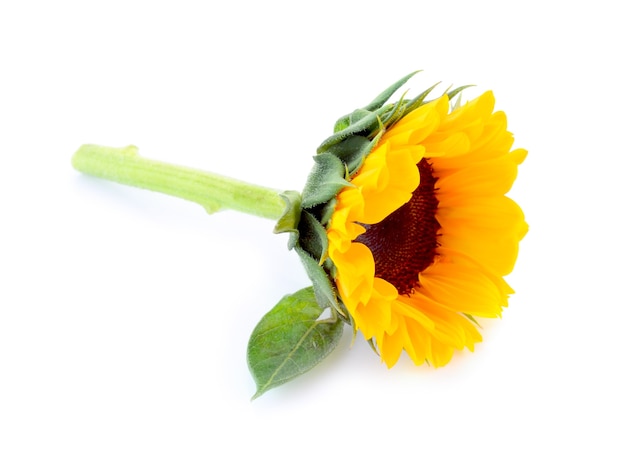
[327, 92, 528, 367]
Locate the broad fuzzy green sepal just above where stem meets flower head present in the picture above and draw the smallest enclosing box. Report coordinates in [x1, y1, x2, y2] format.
[302, 153, 350, 207]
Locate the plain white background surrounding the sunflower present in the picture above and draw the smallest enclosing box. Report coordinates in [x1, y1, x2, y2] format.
[0, 0, 626, 449]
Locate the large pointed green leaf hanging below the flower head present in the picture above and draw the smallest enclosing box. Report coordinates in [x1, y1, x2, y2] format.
[248, 287, 343, 399]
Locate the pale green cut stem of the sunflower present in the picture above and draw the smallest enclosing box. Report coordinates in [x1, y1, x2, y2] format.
[72, 145, 285, 220]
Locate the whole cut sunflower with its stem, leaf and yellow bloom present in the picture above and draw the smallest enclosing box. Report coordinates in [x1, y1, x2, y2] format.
[72, 72, 528, 397]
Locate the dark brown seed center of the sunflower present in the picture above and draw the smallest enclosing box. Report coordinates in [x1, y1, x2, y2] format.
[356, 159, 441, 295]
